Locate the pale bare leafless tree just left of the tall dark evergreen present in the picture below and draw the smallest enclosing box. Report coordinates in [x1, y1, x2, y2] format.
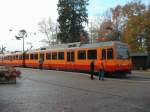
[38, 17, 56, 45]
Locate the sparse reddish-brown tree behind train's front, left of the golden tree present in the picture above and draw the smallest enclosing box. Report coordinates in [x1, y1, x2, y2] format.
[98, 6, 121, 41]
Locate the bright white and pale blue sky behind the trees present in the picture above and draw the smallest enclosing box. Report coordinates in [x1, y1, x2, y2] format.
[0, 0, 149, 51]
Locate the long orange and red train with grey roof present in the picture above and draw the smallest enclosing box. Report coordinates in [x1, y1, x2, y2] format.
[0, 41, 131, 75]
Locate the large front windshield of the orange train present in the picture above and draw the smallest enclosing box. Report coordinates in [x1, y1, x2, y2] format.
[116, 46, 130, 59]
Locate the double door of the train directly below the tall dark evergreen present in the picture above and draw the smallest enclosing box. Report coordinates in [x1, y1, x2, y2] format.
[67, 51, 75, 69]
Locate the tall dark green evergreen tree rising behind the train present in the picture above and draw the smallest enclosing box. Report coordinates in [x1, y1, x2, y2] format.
[57, 0, 89, 43]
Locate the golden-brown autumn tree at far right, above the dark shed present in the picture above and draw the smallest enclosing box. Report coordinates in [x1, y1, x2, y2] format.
[123, 7, 150, 53]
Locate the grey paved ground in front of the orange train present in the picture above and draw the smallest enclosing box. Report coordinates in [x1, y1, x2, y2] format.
[0, 68, 150, 112]
